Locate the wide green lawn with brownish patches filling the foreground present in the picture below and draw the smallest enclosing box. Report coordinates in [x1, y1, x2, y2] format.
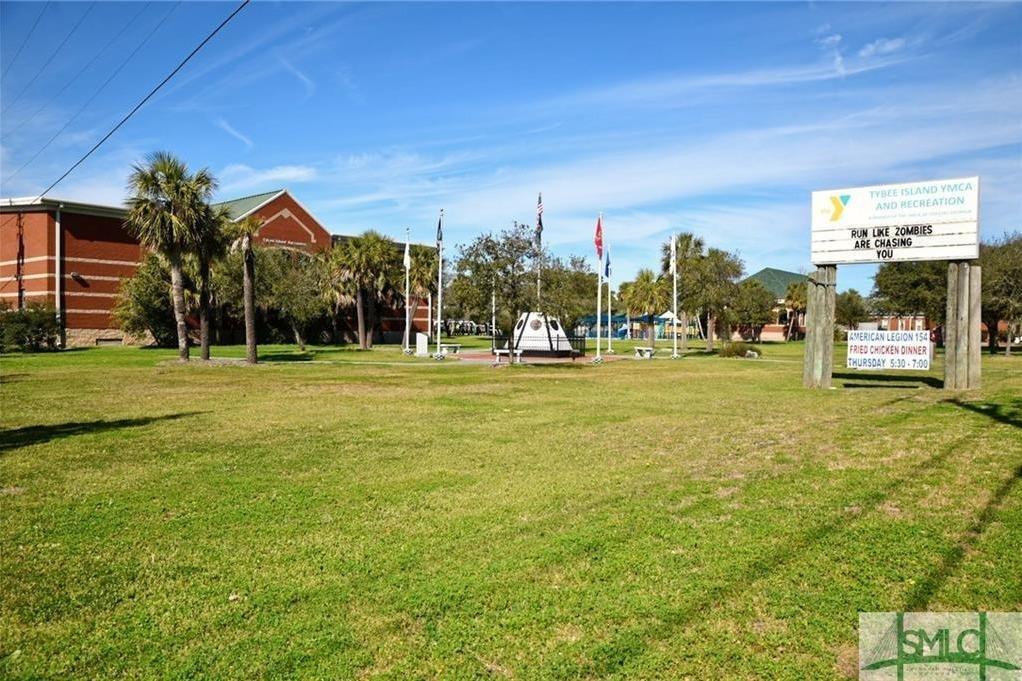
[0, 344, 1022, 679]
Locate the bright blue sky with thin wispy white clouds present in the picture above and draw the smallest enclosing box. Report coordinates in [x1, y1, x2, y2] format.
[0, 2, 1022, 291]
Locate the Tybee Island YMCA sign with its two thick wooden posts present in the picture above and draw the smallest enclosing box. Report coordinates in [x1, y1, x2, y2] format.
[802, 177, 981, 390]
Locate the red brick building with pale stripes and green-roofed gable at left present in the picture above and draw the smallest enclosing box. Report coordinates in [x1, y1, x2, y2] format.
[0, 189, 429, 346]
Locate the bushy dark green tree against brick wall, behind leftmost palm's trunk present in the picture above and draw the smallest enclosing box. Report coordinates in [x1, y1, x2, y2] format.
[113, 253, 177, 348]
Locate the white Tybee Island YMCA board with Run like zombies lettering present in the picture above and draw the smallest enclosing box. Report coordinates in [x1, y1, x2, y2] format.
[812, 177, 979, 265]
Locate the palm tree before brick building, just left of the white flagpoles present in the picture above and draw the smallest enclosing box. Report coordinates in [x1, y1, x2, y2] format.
[330, 230, 400, 350]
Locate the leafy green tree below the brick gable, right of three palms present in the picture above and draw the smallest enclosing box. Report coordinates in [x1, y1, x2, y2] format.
[265, 248, 327, 351]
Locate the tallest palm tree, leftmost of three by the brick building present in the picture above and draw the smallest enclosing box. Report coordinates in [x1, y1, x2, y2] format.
[125, 151, 217, 361]
